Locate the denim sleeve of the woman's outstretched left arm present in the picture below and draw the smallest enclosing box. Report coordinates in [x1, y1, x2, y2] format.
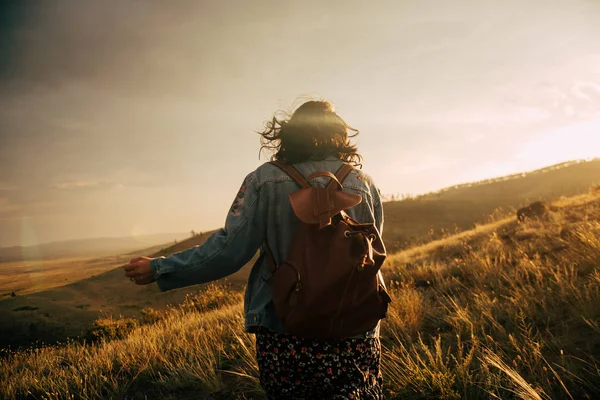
[150, 172, 266, 291]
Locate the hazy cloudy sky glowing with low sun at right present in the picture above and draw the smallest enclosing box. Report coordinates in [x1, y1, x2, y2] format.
[0, 0, 600, 246]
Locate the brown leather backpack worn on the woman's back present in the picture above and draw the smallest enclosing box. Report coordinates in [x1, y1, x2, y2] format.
[264, 161, 391, 338]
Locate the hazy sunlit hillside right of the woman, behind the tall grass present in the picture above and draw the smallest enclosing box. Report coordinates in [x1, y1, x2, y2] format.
[384, 159, 600, 252]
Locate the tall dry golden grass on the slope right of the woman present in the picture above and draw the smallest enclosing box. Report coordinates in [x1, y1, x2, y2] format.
[383, 193, 600, 399]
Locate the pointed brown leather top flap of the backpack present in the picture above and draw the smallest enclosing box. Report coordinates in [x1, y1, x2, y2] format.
[289, 187, 362, 229]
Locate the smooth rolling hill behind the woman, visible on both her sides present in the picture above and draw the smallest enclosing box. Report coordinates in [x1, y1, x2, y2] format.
[0, 160, 600, 347]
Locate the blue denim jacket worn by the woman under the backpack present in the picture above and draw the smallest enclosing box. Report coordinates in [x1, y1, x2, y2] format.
[150, 157, 383, 337]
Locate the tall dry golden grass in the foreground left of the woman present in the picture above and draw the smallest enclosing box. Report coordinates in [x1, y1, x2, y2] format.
[0, 286, 258, 399]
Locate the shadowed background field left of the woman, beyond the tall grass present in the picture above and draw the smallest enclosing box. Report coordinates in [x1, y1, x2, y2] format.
[0, 228, 255, 348]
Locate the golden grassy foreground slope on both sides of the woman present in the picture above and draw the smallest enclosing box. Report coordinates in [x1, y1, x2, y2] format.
[0, 186, 600, 399]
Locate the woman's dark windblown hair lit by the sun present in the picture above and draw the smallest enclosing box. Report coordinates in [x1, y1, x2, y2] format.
[258, 100, 362, 167]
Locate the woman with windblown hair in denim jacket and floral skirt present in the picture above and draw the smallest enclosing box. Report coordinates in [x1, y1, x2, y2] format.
[124, 101, 383, 399]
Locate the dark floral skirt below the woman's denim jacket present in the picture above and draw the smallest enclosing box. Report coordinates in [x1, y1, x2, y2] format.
[256, 328, 383, 400]
